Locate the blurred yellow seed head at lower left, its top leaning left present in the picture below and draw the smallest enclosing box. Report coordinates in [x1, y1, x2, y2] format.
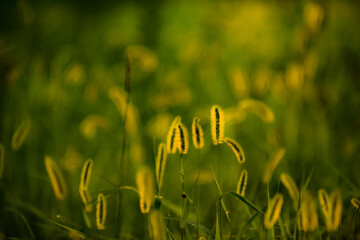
[45, 156, 67, 200]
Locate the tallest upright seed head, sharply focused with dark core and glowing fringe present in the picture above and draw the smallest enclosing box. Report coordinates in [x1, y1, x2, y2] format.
[210, 105, 225, 145]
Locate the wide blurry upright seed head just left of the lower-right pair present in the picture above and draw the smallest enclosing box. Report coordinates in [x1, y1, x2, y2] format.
[298, 190, 319, 232]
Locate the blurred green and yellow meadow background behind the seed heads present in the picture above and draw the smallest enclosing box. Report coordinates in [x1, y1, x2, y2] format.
[0, 0, 360, 239]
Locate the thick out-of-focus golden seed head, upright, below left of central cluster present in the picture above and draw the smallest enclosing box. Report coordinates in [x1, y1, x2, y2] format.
[136, 166, 154, 213]
